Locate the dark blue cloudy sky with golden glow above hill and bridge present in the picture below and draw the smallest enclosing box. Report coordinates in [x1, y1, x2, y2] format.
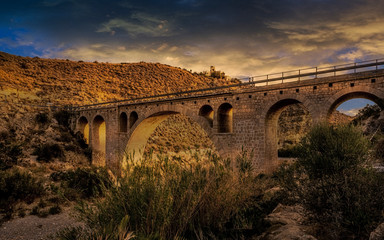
[0, 0, 384, 113]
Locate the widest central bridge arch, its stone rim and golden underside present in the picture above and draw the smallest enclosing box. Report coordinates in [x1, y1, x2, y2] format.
[123, 106, 217, 164]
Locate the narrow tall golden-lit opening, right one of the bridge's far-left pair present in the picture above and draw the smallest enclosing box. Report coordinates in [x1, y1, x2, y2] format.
[92, 115, 106, 166]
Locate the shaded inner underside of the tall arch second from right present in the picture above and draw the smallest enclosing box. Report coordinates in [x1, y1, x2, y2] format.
[263, 98, 313, 172]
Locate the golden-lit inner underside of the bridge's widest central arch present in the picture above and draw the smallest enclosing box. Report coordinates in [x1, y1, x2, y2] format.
[122, 110, 217, 165]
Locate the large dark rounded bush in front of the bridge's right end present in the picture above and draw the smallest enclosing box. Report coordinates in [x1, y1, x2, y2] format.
[282, 124, 384, 239]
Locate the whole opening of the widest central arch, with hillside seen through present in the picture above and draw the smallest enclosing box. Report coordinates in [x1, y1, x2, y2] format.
[123, 111, 215, 164]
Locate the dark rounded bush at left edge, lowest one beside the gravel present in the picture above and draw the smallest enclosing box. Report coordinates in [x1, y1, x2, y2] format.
[0, 169, 44, 217]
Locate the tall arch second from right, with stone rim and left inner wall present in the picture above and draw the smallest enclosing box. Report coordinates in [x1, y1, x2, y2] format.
[262, 96, 315, 171]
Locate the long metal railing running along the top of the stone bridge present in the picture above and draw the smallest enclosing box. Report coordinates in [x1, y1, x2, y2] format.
[73, 58, 384, 110]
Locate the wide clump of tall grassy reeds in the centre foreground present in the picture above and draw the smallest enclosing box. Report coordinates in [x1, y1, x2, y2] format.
[60, 155, 277, 239]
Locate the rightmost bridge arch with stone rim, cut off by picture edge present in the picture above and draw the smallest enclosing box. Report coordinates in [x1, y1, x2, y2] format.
[324, 86, 384, 121]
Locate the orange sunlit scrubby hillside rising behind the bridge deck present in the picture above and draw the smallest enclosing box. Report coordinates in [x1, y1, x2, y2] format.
[0, 52, 238, 105]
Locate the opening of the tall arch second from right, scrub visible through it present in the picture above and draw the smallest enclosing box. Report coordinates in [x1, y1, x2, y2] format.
[265, 99, 312, 170]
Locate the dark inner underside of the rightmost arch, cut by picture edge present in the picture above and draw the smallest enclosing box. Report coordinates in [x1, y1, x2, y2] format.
[326, 91, 384, 122]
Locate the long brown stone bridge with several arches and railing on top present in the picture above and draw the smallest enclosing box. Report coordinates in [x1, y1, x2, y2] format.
[72, 60, 384, 171]
